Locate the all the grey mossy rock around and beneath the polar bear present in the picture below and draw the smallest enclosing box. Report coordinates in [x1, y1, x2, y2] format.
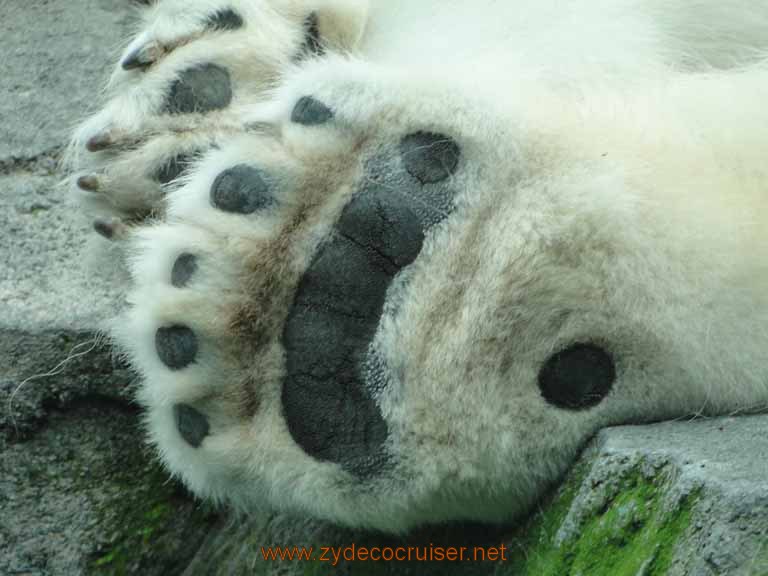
[0, 0, 768, 576]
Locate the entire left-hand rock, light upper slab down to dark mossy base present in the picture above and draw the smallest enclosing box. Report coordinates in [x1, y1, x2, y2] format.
[0, 0, 216, 576]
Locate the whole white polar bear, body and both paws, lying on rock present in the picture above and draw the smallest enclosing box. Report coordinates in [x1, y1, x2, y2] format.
[72, 0, 768, 532]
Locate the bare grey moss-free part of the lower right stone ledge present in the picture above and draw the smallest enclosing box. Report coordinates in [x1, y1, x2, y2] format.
[556, 416, 768, 576]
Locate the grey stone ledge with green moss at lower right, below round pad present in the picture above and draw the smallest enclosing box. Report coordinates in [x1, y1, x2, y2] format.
[510, 416, 768, 576]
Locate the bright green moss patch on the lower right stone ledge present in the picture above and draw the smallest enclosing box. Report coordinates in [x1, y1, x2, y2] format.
[497, 467, 696, 576]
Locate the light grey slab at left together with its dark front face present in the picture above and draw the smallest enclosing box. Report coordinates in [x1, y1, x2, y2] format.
[0, 0, 134, 433]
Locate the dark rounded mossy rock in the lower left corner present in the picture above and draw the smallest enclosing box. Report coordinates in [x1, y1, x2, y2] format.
[0, 396, 213, 576]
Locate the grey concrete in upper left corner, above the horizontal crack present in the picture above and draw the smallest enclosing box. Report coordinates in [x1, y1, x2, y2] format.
[0, 0, 131, 165]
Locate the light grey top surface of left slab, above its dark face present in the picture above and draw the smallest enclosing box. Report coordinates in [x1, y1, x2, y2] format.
[0, 0, 133, 331]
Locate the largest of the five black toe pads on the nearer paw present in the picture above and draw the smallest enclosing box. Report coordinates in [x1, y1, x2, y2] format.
[211, 164, 275, 214]
